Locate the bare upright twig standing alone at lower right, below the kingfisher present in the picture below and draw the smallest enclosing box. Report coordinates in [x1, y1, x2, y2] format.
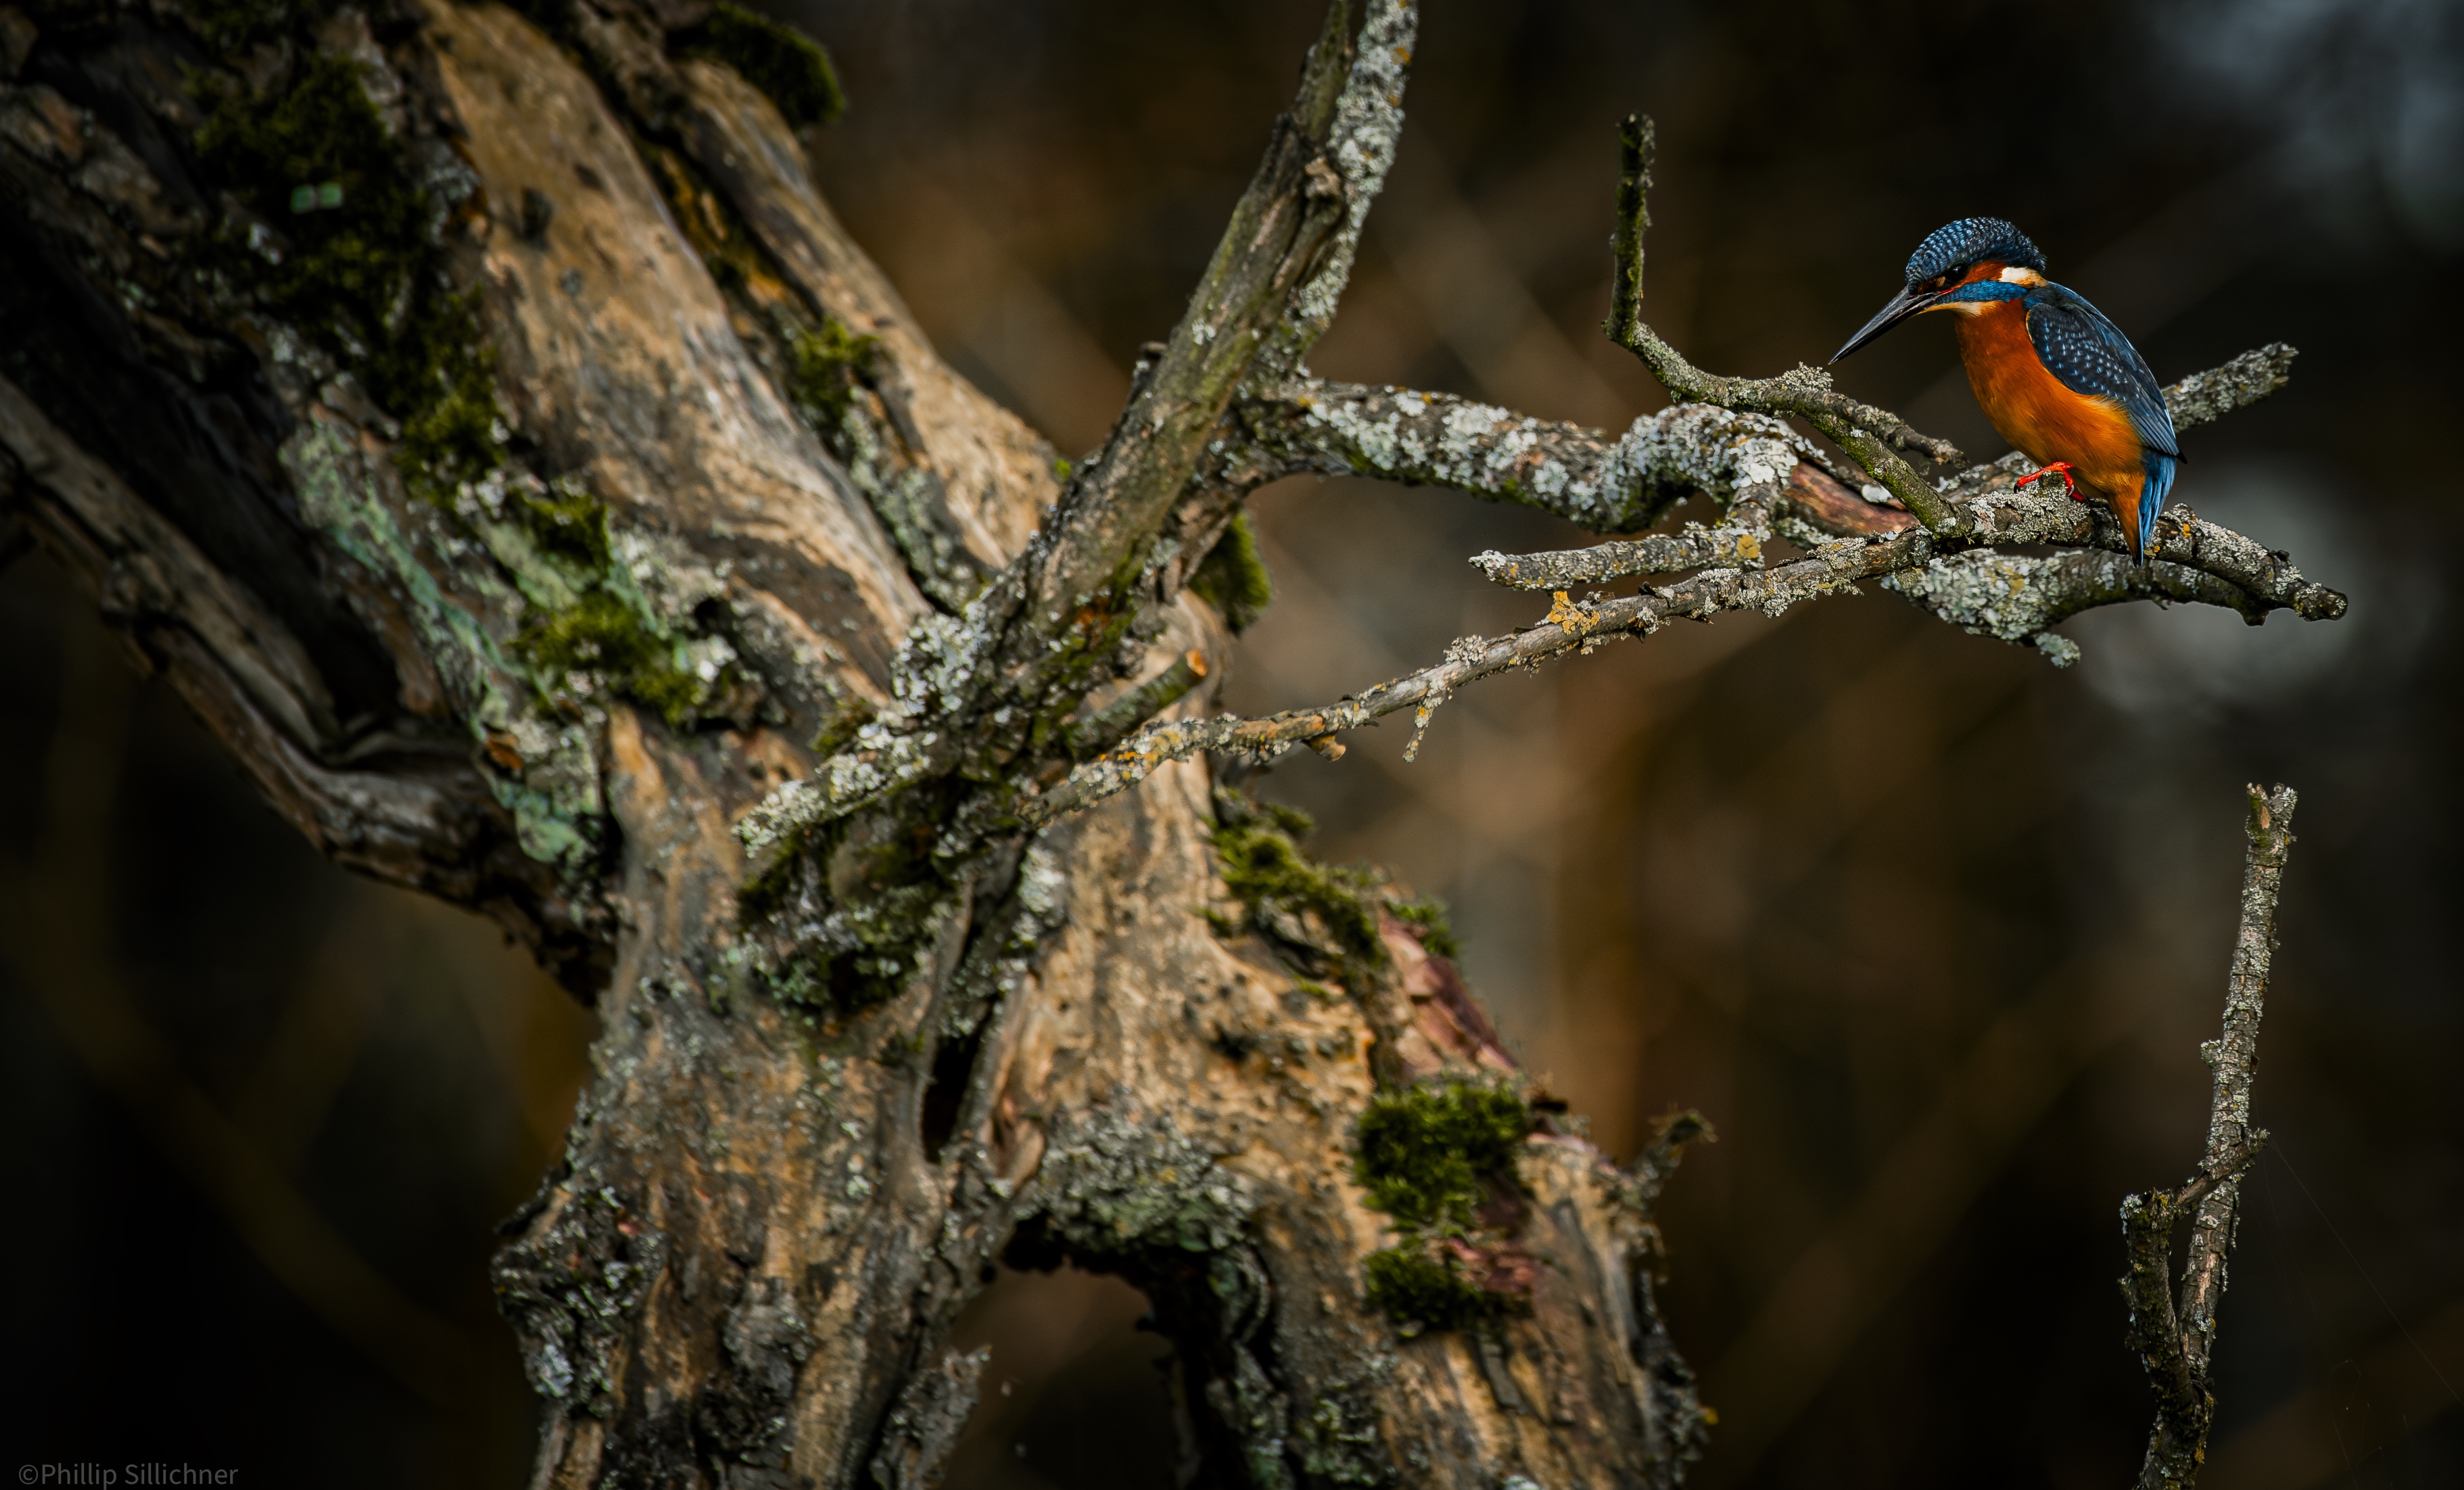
[2121, 786, 2299, 1490]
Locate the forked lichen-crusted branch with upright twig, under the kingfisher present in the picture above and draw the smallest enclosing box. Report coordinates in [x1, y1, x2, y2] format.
[1020, 116, 2346, 827]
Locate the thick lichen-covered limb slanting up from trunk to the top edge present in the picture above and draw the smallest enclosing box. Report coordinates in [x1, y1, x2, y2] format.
[742, 0, 1417, 855]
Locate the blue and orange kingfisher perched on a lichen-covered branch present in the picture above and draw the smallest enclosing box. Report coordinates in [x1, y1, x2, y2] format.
[1830, 216, 2183, 561]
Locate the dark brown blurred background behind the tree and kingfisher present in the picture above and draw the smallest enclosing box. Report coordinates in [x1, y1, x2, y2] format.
[0, 0, 2464, 1490]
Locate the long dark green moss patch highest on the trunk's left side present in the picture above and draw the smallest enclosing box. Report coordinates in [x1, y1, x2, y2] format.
[197, 55, 505, 500]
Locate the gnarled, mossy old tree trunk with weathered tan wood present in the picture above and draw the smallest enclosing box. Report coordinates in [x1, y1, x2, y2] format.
[0, 0, 1703, 1490]
